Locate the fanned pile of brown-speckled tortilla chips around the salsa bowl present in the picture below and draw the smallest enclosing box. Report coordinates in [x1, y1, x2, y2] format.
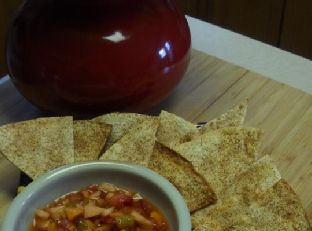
[0, 101, 311, 231]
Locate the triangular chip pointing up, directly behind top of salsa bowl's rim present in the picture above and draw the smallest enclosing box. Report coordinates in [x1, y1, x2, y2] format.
[100, 118, 159, 166]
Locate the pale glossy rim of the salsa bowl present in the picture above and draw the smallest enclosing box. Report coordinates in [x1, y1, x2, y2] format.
[0, 160, 192, 231]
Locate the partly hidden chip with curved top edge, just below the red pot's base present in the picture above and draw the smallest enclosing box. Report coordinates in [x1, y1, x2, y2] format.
[93, 112, 151, 150]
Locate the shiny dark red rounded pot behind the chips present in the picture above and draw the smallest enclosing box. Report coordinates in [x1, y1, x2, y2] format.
[7, 0, 191, 115]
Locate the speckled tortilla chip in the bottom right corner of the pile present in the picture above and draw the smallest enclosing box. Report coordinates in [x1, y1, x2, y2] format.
[192, 180, 311, 231]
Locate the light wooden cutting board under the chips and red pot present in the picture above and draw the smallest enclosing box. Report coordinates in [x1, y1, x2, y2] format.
[0, 50, 312, 225]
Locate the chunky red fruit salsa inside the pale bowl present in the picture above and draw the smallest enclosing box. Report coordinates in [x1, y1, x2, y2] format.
[28, 183, 170, 231]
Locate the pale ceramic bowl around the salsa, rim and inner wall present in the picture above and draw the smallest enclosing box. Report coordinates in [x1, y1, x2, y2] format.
[2, 161, 191, 231]
